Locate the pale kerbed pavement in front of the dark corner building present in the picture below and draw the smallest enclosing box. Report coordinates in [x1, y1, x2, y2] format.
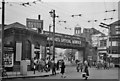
[2, 70, 60, 79]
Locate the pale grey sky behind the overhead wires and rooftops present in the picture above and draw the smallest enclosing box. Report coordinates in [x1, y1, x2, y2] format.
[0, 0, 119, 35]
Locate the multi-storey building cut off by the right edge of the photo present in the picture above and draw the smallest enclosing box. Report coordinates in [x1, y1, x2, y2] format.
[108, 20, 120, 67]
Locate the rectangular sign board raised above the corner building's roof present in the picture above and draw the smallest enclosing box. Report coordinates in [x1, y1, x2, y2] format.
[26, 18, 43, 29]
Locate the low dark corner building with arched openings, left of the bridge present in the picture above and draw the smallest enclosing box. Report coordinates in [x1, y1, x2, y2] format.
[4, 23, 47, 70]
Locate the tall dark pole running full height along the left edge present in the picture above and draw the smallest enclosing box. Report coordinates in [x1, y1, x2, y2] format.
[0, 0, 5, 80]
